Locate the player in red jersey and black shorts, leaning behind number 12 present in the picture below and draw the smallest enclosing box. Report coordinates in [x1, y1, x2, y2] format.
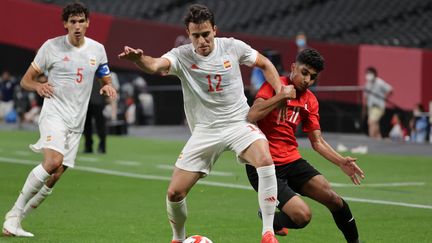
[246, 49, 364, 242]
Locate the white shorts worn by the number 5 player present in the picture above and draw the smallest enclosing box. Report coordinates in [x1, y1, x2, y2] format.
[29, 116, 82, 168]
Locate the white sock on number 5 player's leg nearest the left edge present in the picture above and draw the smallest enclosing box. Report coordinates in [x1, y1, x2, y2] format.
[13, 164, 50, 213]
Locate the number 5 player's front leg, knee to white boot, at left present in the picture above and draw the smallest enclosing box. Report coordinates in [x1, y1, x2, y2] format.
[3, 149, 63, 237]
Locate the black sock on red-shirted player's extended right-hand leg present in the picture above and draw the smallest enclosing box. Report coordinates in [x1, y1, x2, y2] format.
[332, 199, 358, 242]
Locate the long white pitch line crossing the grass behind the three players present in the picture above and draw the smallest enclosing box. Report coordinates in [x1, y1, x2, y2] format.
[0, 157, 432, 209]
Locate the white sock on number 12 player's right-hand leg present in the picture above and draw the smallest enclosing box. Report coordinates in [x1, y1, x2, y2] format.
[257, 165, 277, 234]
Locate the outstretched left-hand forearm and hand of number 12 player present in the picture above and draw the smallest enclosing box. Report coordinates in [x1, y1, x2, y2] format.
[118, 46, 170, 74]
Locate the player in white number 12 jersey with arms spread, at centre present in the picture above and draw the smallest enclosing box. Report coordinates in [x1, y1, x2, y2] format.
[119, 4, 295, 243]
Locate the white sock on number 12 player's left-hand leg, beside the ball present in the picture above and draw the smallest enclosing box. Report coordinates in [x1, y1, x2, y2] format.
[166, 198, 187, 241]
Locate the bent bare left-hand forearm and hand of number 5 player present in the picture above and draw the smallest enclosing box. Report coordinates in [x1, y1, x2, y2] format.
[20, 65, 54, 98]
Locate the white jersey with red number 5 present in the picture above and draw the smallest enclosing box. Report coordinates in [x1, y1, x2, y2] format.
[32, 35, 108, 132]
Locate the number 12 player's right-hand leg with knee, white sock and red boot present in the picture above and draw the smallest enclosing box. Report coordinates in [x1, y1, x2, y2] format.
[241, 139, 278, 242]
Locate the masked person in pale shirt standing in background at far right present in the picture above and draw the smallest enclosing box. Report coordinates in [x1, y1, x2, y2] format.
[365, 67, 393, 139]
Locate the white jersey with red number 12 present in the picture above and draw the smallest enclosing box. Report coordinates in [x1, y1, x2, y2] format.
[162, 38, 258, 131]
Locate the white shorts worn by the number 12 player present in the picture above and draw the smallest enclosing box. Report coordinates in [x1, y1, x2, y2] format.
[175, 121, 267, 175]
